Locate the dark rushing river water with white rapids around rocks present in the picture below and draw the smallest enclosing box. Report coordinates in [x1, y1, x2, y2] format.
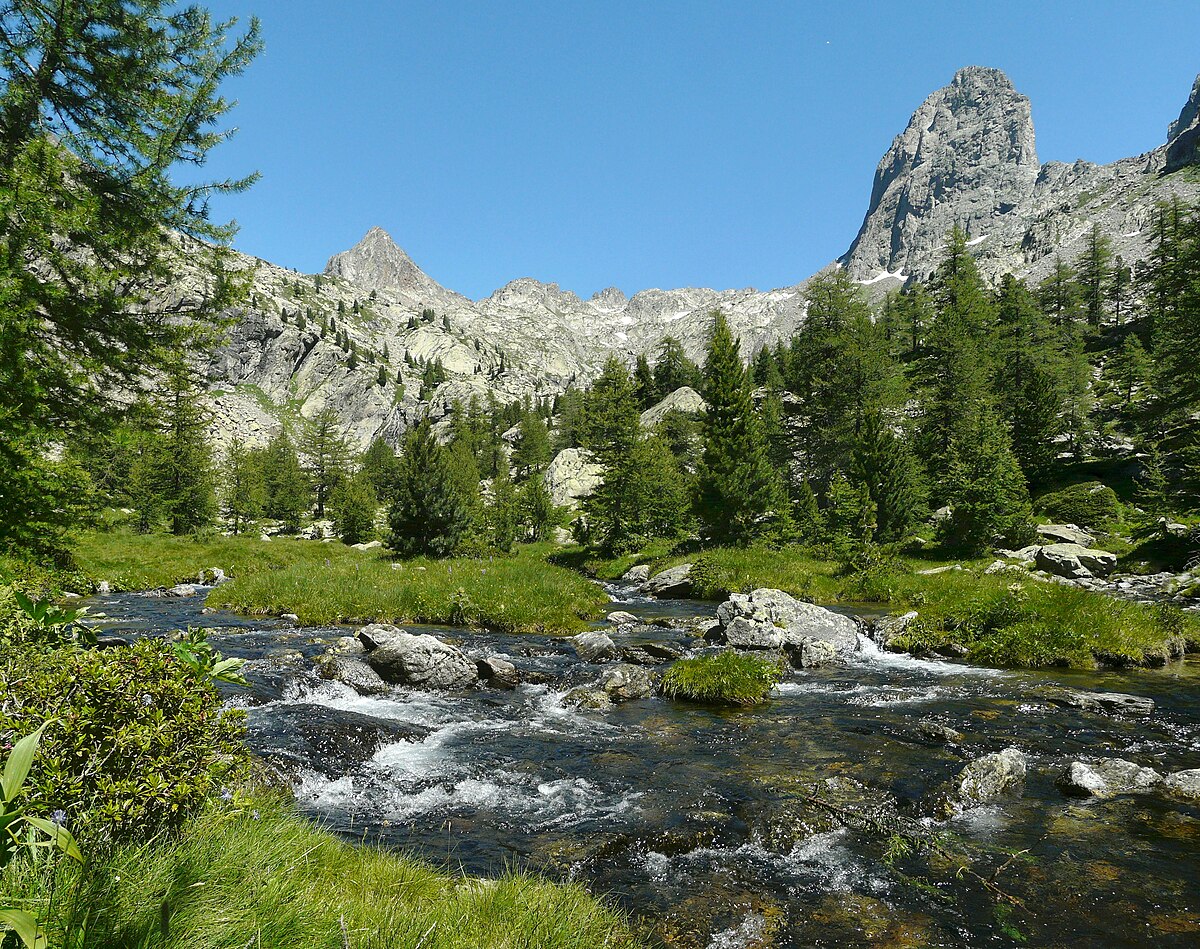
[88, 590, 1200, 949]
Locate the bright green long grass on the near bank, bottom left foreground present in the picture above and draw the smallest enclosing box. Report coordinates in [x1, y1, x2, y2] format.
[0, 800, 640, 949]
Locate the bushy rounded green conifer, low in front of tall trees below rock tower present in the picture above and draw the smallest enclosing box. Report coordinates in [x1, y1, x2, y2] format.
[942, 410, 1033, 554]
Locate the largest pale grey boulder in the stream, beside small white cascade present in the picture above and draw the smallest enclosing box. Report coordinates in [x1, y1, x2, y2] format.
[713, 589, 858, 668]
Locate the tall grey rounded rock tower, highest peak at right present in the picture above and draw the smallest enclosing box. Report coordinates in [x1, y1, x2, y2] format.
[842, 66, 1040, 274]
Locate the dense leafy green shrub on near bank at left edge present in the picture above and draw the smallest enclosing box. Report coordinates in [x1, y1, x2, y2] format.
[0, 639, 246, 837]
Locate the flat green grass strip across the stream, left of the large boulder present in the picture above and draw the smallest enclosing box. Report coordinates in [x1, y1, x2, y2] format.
[209, 545, 608, 632]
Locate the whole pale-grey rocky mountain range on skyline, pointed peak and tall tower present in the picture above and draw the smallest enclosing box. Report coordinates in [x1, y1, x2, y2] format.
[208, 66, 1200, 446]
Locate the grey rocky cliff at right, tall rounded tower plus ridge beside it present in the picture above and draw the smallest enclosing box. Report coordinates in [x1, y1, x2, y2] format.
[841, 66, 1200, 294]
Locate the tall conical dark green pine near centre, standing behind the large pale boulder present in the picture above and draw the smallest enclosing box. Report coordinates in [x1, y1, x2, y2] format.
[697, 313, 788, 543]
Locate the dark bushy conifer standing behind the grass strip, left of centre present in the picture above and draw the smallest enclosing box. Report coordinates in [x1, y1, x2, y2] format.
[388, 419, 472, 557]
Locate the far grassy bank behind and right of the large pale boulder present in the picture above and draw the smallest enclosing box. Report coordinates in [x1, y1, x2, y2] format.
[563, 547, 1200, 668]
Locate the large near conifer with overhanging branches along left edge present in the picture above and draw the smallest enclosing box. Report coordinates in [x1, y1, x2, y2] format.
[0, 0, 260, 545]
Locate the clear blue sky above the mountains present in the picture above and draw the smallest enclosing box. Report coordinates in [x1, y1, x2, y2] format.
[201, 0, 1200, 298]
